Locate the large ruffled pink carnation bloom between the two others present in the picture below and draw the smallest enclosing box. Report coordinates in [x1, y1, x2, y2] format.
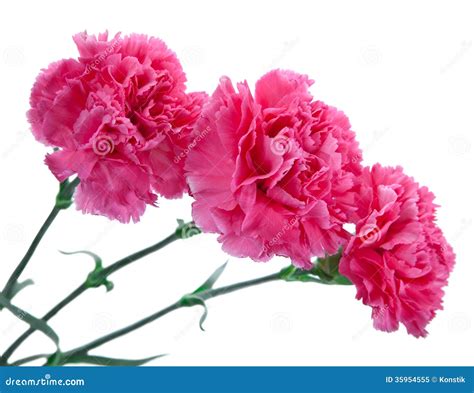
[185, 70, 361, 268]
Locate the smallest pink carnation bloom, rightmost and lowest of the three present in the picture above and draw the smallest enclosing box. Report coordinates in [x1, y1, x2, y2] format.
[339, 165, 455, 337]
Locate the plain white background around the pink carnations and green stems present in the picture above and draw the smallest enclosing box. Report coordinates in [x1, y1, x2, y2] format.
[0, 0, 474, 365]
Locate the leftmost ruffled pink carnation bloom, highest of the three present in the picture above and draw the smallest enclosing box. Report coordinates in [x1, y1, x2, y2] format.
[28, 33, 205, 222]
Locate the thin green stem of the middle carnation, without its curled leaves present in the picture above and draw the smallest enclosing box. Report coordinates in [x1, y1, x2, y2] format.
[0, 231, 181, 365]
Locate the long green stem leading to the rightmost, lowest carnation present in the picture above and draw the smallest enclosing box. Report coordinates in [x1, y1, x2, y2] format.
[62, 272, 282, 362]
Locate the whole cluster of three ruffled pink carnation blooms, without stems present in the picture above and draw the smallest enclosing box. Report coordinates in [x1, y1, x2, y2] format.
[28, 33, 455, 337]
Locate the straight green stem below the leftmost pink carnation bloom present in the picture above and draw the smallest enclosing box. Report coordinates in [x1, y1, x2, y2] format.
[2, 178, 79, 299]
